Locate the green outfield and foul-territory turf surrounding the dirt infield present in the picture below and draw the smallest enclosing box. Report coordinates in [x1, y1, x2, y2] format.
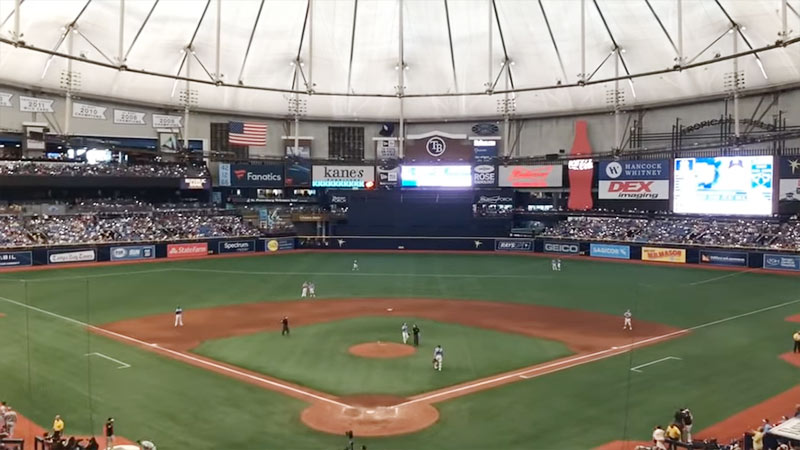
[0, 253, 800, 450]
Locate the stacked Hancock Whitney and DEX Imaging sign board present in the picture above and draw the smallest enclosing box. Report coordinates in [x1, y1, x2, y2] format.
[598, 160, 670, 200]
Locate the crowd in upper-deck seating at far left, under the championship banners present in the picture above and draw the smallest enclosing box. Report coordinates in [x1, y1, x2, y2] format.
[0, 160, 211, 178]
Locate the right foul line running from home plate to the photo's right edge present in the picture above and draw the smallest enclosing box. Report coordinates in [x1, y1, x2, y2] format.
[397, 299, 800, 406]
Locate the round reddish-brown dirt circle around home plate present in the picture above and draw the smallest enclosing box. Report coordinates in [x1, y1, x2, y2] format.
[300, 395, 439, 437]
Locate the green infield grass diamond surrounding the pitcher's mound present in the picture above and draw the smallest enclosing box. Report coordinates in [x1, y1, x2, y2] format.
[193, 317, 572, 396]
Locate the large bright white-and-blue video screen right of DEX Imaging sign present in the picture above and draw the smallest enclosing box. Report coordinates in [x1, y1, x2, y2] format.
[673, 156, 773, 215]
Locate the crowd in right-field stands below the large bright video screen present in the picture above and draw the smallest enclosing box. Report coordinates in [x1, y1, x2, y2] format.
[542, 216, 800, 250]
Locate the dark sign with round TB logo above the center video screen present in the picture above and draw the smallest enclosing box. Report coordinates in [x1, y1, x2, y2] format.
[403, 131, 474, 163]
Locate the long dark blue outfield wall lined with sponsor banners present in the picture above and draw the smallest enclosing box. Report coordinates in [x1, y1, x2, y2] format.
[0, 236, 800, 272]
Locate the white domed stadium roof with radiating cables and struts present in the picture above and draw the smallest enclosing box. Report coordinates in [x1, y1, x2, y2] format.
[0, 0, 800, 119]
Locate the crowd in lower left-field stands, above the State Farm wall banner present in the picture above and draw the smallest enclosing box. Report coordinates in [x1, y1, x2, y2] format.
[0, 211, 261, 247]
